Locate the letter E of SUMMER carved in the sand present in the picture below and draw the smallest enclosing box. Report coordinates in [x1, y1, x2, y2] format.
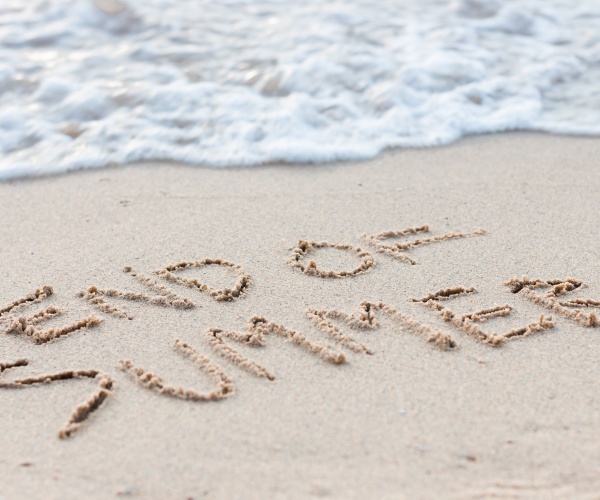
[412, 286, 554, 346]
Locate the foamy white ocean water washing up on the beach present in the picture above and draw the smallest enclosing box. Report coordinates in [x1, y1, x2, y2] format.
[0, 0, 600, 179]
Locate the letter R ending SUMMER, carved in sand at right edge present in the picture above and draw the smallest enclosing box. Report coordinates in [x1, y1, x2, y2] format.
[505, 276, 600, 327]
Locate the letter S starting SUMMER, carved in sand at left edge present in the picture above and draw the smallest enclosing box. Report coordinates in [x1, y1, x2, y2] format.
[0, 359, 114, 439]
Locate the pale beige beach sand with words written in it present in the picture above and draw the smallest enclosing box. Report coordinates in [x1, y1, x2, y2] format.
[0, 133, 600, 500]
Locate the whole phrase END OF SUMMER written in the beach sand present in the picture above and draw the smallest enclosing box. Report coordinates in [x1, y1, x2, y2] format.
[0, 226, 600, 438]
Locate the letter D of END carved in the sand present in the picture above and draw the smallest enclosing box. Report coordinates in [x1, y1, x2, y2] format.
[156, 259, 251, 302]
